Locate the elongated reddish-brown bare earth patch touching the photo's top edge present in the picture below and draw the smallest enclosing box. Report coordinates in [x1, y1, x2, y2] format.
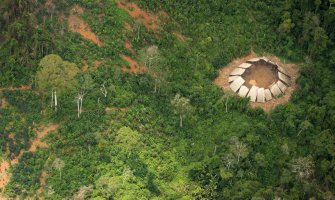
[116, 0, 163, 30]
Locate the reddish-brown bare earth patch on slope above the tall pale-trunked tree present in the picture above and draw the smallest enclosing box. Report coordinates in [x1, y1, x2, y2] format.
[68, 5, 102, 47]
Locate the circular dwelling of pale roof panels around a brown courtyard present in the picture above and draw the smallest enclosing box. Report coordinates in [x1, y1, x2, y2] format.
[228, 57, 291, 103]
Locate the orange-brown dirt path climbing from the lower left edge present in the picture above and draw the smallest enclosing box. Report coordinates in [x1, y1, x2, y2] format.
[0, 124, 59, 200]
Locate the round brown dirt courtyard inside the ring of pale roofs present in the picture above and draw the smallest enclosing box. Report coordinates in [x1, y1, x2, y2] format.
[242, 64, 279, 88]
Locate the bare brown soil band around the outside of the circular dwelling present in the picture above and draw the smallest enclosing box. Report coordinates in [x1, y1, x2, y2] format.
[214, 51, 299, 112]
